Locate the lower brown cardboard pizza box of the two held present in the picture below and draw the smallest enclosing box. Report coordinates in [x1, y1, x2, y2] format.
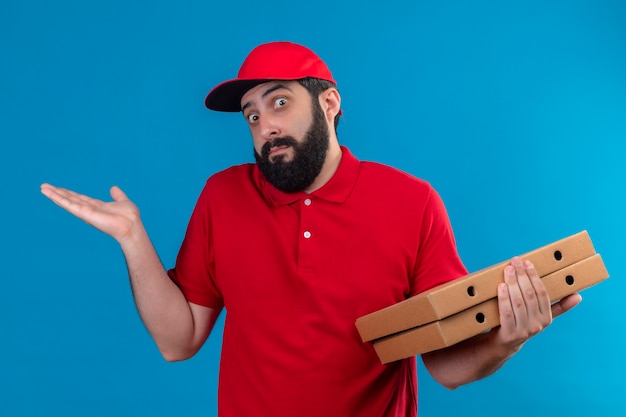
[373, 255, 609, 363]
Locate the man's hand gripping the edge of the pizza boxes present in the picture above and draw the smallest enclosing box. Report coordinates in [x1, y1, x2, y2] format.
[495, 257, 581, 350]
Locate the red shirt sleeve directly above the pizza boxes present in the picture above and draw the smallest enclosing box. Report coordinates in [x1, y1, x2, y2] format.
[411, 188, 467, 295]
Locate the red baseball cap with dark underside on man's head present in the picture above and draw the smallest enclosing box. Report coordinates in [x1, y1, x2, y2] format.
[204, 42, 337, 112]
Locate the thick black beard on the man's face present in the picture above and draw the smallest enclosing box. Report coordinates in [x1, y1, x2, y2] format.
[254, 100, 330, 193]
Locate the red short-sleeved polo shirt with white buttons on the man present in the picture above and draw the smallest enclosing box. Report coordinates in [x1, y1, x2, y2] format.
[169, 147, 467, 417]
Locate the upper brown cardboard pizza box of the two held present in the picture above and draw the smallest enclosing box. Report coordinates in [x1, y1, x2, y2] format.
[356, 231, 595, 342]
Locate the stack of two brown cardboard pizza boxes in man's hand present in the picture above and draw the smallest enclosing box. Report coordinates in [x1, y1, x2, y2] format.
[356, 231, 608, 363]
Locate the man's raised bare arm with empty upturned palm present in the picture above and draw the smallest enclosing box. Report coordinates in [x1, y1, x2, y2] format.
[41, 184, 220, 361]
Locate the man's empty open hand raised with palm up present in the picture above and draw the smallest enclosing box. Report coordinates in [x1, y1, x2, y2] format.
[41, 184, 139, 242]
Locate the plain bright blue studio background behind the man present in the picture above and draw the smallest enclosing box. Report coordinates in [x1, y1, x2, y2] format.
[0, 0, 626, 417]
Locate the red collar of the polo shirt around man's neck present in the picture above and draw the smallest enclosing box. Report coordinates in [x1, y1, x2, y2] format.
[254, 146, 359, 206]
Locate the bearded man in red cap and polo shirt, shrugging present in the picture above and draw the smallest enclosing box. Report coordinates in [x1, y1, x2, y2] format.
[42, 42, 580, 417]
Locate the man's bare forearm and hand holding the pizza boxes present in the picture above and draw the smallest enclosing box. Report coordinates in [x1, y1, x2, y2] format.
[422, 258, 581, 389]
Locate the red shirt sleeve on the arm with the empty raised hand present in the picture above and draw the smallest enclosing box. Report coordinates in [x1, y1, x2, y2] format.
[168, 183, 224, 308]
